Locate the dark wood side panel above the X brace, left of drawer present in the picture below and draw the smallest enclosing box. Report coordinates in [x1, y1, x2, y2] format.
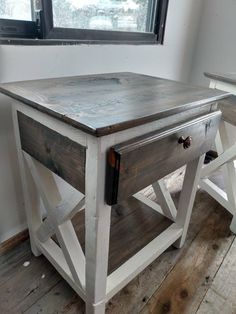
[18, 112, 86, 193]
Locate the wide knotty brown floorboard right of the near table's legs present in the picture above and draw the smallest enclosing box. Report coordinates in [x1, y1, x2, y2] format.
[141, 202, 234, 314]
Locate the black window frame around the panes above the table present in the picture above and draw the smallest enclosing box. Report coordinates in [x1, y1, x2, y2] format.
[0, 0, 169, 44]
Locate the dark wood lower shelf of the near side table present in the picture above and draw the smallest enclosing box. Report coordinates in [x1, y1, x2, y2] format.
[54, 197, 173, 274]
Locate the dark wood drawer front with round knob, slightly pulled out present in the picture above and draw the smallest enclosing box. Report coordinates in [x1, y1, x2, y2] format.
[106, 111, 221, 205]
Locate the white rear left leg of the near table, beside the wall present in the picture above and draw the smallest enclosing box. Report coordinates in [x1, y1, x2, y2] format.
[12, 106, 42, 256]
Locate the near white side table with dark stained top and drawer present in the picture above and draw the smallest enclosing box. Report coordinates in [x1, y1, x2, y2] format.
[0, 73, 228, 314]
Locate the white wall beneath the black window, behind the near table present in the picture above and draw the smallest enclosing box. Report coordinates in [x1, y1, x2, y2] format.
[0, 0, 202, 242]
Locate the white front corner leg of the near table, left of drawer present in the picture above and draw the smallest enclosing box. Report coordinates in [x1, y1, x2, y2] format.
[85, 138, 111, 314]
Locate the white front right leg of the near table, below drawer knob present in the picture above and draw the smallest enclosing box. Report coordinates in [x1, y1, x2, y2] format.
[174, 155, 205, 248]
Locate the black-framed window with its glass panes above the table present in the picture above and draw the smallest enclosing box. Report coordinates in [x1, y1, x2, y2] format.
[0, 0, 168, 43]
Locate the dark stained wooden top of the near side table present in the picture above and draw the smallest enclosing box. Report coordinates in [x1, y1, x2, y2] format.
[0, 73, 228, 136]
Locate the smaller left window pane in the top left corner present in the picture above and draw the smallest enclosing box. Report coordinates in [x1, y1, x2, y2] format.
[0, 0, 32, 21]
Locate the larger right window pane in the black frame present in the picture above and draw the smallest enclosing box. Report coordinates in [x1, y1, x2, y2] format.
[52, 0, 156, 32]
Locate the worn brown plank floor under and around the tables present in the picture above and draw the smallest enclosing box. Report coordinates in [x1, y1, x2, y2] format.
[0, 171, 236, 314]
